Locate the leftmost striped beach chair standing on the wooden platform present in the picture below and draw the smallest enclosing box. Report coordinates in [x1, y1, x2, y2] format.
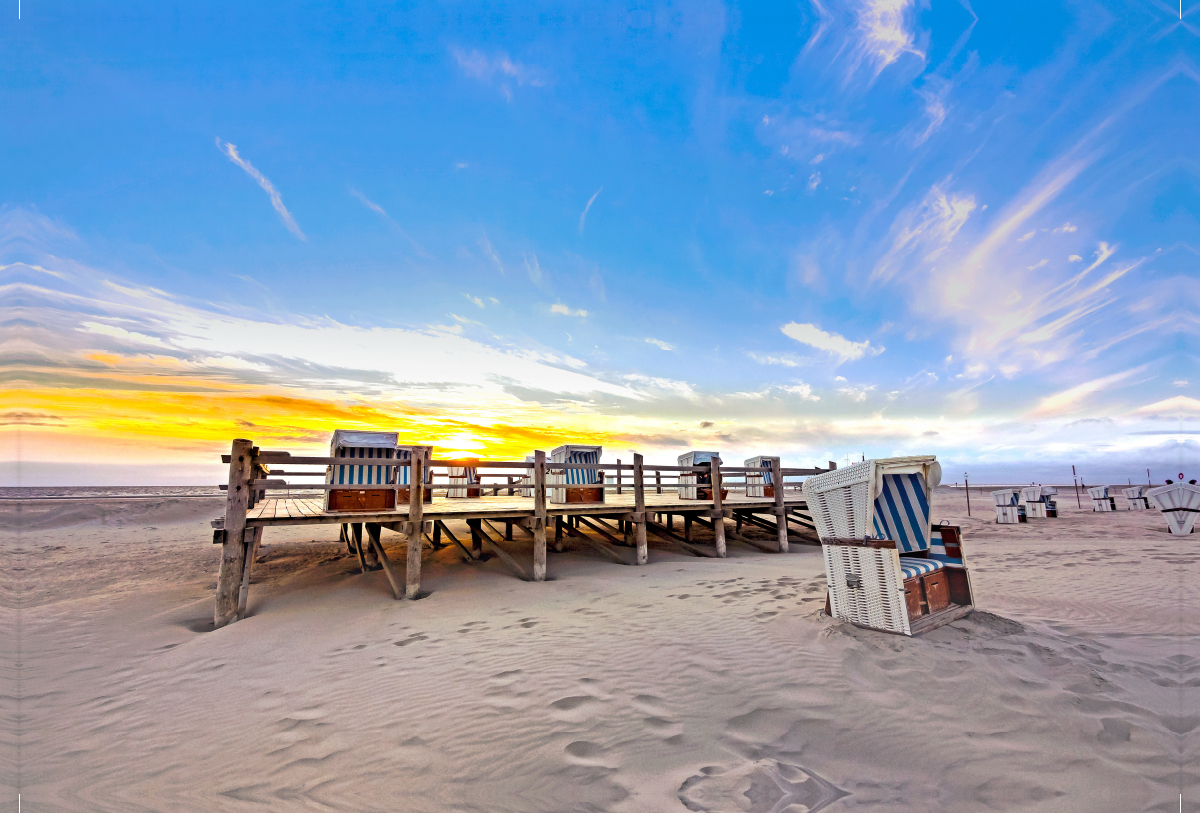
[325, 429, 408, 511]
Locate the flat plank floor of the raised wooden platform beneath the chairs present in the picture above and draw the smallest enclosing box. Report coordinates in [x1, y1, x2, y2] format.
[246, 493, 808, 525]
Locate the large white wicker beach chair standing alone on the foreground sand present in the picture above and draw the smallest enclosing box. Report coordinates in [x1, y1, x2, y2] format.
[804, 456, 973, 636]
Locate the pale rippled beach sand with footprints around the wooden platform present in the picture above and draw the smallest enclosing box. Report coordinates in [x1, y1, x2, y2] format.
[0, 489, 1200, 813]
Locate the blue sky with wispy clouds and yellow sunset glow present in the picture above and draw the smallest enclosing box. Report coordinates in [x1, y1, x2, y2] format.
[0, 0, 1200, 486]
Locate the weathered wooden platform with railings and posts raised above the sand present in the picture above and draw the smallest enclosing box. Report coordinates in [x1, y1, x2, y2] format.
[212, 440, 828, 627]
